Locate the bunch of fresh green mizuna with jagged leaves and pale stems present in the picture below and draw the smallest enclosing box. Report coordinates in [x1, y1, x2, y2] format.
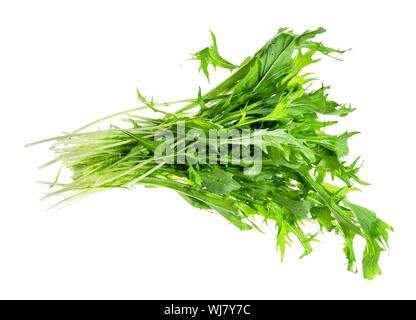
[30, 28, 392, 279]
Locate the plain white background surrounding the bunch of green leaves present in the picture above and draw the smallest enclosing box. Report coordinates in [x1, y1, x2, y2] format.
[0, 0, 416, 299]
